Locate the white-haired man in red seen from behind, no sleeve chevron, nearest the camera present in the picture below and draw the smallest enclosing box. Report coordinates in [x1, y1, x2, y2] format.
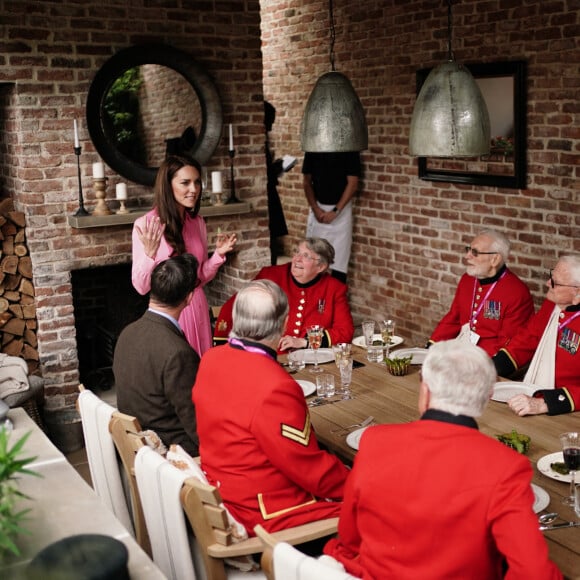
[324, 340, 562, 580]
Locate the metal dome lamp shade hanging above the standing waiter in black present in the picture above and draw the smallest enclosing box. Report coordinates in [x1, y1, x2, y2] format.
[300, 71, 369, 153]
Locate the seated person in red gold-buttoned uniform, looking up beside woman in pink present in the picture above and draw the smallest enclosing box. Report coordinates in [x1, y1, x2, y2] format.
[214, 238, 354, 352]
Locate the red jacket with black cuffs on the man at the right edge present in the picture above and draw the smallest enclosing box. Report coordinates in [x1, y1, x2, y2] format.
[494, 300, 580, 415]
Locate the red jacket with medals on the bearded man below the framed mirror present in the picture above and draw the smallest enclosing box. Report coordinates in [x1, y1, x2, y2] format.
[429, 267, 534, 356]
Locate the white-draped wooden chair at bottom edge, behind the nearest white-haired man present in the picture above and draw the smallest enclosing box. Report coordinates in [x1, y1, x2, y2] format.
[254, 525, 360, 580]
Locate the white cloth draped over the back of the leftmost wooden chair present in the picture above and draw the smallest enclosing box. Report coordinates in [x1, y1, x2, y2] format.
[76, 385, 135, 536]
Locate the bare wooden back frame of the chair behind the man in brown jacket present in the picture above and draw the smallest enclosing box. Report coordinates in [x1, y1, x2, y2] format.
[109, 411, 151, 556]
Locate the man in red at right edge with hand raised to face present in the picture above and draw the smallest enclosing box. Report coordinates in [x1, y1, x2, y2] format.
[493, 256, 580, 415]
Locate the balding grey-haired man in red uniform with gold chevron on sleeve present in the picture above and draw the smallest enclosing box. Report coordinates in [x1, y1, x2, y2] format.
[193, 280, 348, 535]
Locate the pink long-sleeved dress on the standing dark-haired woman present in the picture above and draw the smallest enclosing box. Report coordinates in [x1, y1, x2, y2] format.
[131, 208, 226, 356]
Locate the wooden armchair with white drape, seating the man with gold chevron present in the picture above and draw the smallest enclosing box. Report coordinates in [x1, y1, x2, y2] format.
[136, 448, 338, 580]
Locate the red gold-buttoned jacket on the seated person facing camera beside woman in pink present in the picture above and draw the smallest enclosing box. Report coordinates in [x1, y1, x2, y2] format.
[214, 264, 354, 347]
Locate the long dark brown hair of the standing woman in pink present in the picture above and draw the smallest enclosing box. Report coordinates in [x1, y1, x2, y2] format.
[153, 155, 203, 254]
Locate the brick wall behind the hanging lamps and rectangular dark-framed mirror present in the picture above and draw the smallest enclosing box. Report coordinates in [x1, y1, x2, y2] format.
[261, 0, 580, 345]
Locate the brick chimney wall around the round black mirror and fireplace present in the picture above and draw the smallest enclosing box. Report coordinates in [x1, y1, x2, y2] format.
[0, 0, 269, 408]
